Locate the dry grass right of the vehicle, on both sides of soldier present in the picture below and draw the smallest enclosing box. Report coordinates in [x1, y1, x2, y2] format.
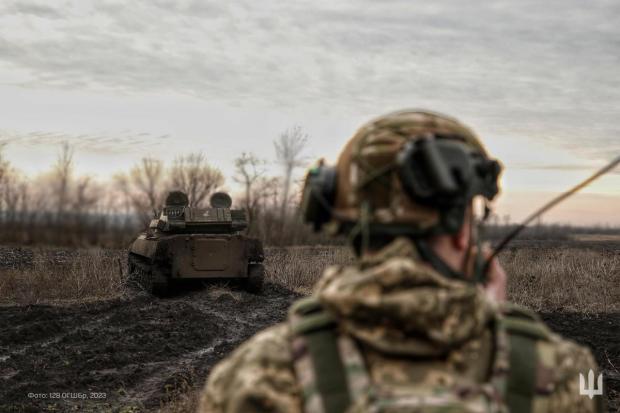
[267, 247, 620, 313]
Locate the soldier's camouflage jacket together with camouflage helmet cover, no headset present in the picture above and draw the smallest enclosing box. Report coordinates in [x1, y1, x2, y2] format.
[199, 112, 602, 413]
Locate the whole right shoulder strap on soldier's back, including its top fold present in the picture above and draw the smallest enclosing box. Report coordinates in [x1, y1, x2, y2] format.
[501, 305, 553, 413]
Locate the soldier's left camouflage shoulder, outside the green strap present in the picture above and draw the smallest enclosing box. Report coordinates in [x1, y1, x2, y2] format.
[199, 324, 299, 412]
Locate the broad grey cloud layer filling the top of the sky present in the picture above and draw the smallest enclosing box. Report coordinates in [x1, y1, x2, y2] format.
[0, 0, 620, 159]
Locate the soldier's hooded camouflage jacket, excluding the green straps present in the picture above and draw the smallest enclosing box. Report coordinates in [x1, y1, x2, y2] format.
[199, 239, 601, 413]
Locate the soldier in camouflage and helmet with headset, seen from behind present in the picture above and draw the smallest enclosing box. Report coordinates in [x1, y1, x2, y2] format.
[199, 111, 603, 413]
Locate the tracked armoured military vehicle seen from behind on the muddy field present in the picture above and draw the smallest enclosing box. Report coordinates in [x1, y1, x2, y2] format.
[128, 191, 264, 295]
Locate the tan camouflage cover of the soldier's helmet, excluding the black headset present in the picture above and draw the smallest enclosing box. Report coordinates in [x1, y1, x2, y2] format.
[327, 110, 496, 233]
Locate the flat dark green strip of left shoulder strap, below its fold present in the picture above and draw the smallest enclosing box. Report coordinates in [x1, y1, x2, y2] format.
[305, 318, 351, 413]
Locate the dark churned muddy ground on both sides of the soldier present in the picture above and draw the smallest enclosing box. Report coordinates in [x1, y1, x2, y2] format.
[0, 284, 620, 412]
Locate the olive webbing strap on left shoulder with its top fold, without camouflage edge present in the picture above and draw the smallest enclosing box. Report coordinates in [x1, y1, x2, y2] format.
[291, 297, 351, 413]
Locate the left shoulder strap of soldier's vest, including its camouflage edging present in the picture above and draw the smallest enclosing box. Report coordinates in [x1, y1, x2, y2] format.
[289, 297, 351, 413]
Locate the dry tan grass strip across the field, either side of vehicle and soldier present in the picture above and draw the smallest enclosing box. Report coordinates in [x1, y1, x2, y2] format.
[0, 246, 620, 313]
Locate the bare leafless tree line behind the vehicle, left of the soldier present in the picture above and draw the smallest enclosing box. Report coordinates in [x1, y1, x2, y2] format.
[0, 126, 340, 247]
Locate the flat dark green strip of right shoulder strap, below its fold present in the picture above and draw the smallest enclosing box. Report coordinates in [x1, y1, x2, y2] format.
[506, 326, 538, 413]
